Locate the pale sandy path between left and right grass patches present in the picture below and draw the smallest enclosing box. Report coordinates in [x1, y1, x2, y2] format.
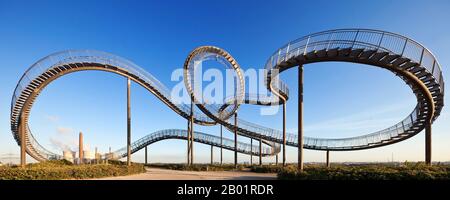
[98, 168, 277, 180]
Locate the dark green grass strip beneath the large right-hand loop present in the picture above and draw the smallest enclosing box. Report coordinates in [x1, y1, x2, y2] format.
[276, 163, 450, 180]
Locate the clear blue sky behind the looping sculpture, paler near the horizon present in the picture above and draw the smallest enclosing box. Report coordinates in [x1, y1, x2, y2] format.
[0, 0, 450, 162]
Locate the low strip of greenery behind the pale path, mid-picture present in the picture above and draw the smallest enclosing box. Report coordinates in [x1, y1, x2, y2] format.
[146, 163, 247, 171]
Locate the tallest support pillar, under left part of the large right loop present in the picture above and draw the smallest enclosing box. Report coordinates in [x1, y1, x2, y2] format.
[298, 65, 303, 172]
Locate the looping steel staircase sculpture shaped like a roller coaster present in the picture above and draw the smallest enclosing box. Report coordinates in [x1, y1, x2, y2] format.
[11, 29, 444, 166]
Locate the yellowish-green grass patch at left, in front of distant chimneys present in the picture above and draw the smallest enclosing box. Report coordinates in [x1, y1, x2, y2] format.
[0, 160, 145, 180]
